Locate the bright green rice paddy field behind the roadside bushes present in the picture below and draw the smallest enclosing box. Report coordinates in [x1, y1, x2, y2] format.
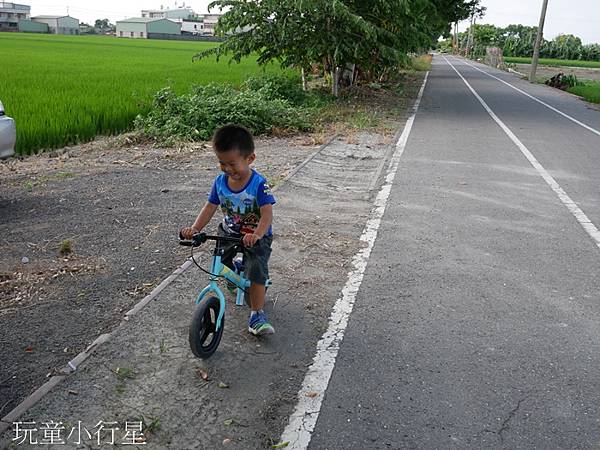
[0, 33, 278, 154]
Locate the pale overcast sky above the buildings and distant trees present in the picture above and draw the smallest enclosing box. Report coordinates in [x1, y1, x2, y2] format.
[29, 0, 600, 43]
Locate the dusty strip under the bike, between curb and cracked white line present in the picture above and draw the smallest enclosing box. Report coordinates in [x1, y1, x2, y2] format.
[1, 127, 408, 449]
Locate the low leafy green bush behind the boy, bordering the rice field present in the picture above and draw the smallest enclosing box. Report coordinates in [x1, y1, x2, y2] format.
[135, 77, 313, 144]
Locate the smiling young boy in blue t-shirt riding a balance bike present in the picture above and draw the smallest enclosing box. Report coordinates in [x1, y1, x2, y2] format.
[181, 125, 275, 335]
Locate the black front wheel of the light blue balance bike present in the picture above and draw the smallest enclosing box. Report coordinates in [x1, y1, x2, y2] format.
[189, 297, 225, 359]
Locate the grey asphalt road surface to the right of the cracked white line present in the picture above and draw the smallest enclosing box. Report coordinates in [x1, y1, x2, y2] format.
[309, 56, 600, 449]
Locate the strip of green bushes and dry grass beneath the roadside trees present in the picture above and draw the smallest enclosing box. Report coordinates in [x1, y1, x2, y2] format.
[135, 55, 431, 146]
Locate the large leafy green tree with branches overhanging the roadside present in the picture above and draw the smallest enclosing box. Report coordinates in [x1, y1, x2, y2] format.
[196, 0, 478, 95]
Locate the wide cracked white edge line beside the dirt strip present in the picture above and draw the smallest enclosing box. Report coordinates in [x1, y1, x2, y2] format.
[281, 72, 429, 449]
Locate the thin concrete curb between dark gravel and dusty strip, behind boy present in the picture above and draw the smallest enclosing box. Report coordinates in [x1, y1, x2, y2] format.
[0, 134, 338, 444]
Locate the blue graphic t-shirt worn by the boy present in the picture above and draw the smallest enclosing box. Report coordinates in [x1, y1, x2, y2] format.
[208, 169, 275, 236]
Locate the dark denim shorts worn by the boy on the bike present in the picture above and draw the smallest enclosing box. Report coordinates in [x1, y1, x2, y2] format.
[217, 224, 273, 285]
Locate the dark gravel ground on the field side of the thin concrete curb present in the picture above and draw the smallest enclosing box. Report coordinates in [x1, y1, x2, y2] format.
[0, 137, 318, 417]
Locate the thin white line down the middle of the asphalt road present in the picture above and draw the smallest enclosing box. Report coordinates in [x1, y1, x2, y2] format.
[443, 56, 600, 248]
